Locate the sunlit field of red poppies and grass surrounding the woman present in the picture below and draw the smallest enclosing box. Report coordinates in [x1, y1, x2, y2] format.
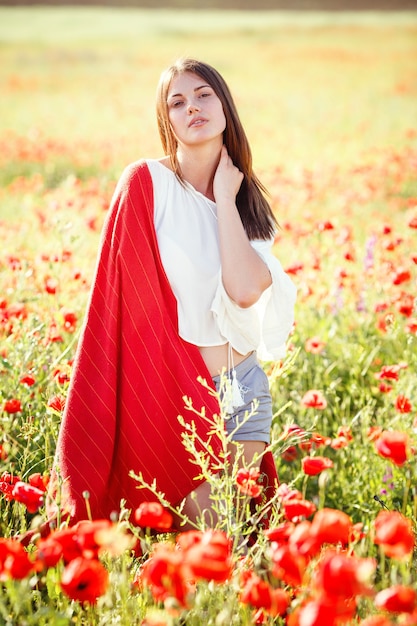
[0, 7, 417, 626]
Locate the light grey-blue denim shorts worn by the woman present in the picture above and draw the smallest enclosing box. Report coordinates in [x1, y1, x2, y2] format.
[213, 352, 272, 444]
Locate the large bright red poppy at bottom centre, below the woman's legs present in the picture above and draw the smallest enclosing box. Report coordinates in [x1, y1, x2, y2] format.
[185, 530, 233, 583]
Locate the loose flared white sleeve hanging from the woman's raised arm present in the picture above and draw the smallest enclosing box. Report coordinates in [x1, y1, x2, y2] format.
[211, 240, 297, 361]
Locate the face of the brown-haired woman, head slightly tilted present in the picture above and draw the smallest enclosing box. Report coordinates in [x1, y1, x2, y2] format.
[167, 72, 226, 146]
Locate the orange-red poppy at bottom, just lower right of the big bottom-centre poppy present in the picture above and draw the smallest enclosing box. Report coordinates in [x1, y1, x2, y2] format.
[239, 572, 290, 617]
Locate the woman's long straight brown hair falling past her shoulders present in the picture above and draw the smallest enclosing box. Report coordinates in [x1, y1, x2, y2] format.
[156, 58, 277, 239]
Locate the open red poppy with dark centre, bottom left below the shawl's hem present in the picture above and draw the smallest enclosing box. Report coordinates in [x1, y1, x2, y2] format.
[60, 557, 109, 604]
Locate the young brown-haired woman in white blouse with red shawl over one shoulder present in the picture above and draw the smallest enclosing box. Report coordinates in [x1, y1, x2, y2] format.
[46, 59, 295, 521]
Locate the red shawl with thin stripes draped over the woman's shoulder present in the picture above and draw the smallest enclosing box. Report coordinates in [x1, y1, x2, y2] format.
[48, 162, 276, 521]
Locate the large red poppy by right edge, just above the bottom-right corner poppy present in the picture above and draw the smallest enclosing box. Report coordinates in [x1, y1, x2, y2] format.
[374, 511, 415, 559]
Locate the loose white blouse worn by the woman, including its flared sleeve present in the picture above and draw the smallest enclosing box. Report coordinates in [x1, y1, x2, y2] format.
[146, 159, 296, 361]
